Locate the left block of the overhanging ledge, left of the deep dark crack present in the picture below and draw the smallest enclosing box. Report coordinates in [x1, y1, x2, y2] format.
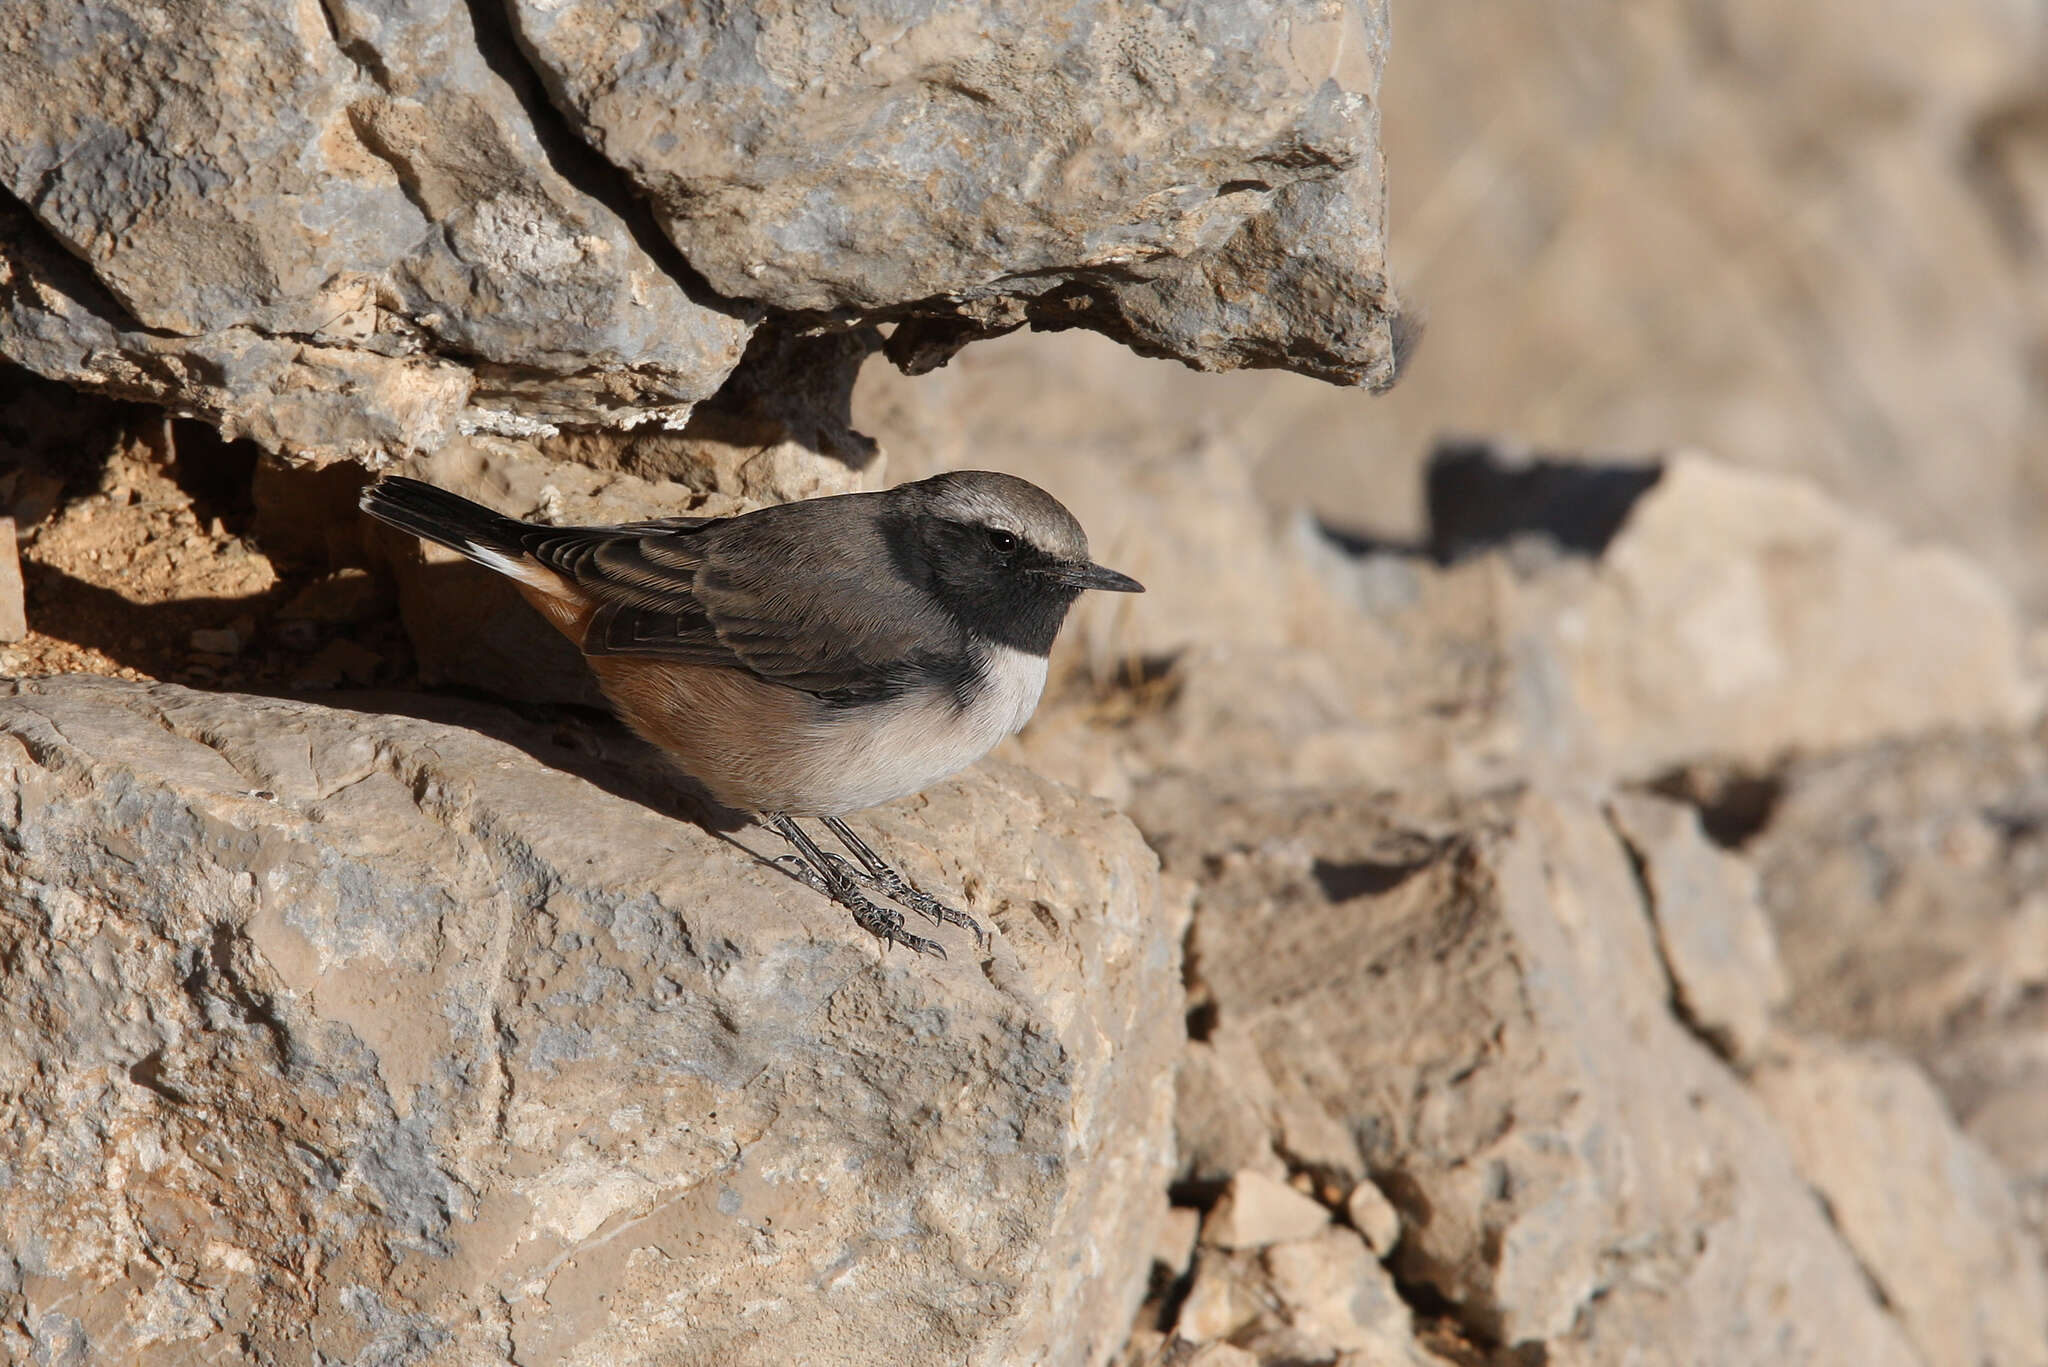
[0, 0, 750, 455]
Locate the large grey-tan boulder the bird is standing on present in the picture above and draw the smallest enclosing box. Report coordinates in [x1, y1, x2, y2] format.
[0, 678, 1180, 1365]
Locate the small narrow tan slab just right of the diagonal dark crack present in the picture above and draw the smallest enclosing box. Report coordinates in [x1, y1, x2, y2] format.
[1608, 793, 1786, 1062]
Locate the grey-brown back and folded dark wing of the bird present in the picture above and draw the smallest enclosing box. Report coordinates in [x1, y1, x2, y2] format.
[512, 494, 965, 703]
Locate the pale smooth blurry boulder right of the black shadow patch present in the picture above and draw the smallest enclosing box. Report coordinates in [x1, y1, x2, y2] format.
[1505, 455, 2040, 775]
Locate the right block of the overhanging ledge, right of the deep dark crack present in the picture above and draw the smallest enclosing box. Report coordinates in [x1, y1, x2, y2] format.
[512, 0, 1397, 385]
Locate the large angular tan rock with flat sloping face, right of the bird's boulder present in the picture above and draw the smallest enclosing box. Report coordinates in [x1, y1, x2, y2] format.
[1135, 779, 1942, 1367]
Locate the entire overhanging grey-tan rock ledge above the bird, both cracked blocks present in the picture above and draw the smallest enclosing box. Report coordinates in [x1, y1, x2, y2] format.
[0, 0, 1397, 463]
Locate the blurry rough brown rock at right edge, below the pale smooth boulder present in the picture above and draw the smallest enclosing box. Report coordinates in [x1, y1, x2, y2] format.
[1745, 730, 2048, 1240]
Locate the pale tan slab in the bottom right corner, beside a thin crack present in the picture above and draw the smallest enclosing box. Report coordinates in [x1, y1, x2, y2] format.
[1755, 1041, 2048, 1367]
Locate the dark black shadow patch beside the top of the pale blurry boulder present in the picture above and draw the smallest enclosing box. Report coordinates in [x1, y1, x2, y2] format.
[1425, 441, 1663, 564]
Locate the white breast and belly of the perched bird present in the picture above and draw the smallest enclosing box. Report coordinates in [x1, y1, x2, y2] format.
[784, 646, 1047, 816]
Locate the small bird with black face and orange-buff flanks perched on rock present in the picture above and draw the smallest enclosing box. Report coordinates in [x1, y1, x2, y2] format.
[362, 469, 1145, 957]
